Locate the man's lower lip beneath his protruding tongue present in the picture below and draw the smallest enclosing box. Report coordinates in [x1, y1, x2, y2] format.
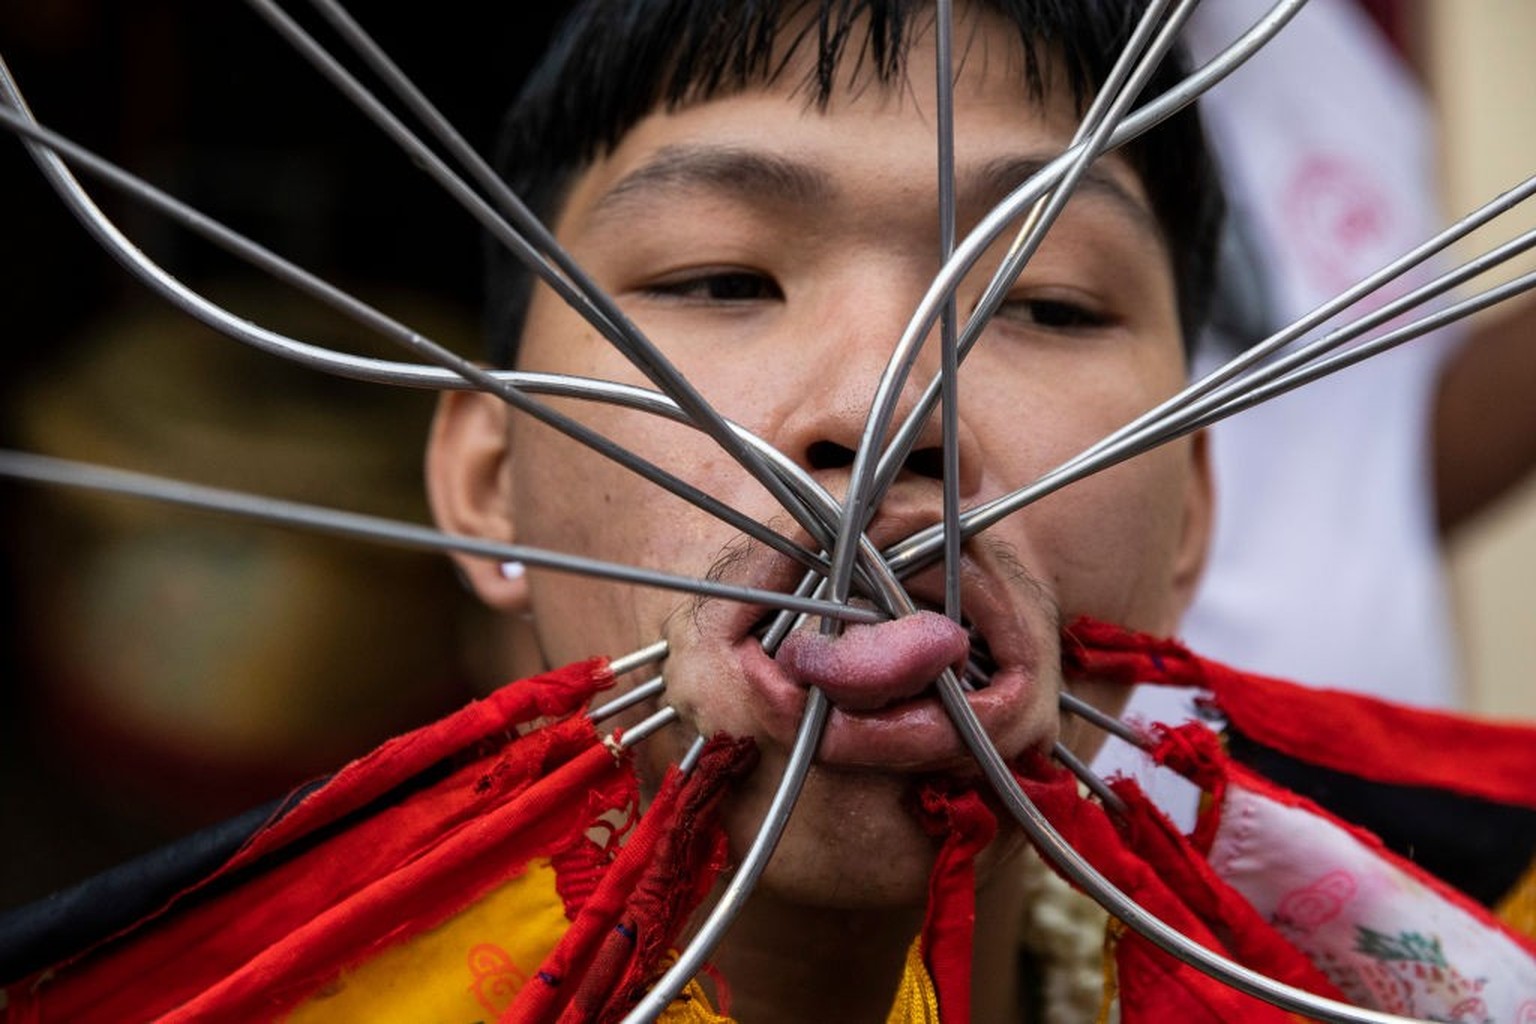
[736, 637, 1029, 772]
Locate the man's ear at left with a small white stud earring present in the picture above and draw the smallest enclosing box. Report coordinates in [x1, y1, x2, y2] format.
[427, 391, 528, 613]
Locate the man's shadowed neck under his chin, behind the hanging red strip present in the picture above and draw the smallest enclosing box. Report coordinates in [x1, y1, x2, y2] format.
[716, 860, 1025, 1024]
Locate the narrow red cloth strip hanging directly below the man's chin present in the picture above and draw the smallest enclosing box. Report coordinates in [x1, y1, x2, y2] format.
[917, 783, 997, 1024]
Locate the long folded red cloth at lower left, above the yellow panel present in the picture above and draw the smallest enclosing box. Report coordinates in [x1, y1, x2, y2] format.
[11, 662, 623, 1022]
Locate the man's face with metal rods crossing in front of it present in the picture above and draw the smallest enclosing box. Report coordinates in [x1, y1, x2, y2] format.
[435, 8, 1206, 903]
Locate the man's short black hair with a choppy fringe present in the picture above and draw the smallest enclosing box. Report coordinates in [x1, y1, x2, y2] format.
[485, 0, 1223, 365]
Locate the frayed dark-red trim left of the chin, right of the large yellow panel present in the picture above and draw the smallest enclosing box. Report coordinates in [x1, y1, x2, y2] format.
[501, 737, 757, 1024]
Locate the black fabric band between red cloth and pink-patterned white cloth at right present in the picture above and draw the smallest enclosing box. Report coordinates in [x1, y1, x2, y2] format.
[1227, 728, 1536, 907]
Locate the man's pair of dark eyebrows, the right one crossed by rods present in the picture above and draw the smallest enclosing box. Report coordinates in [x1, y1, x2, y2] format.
[593, 146, 1164, 244]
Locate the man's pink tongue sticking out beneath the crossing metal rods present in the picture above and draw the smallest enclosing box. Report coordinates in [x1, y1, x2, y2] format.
[777, 611, 971, 711]
